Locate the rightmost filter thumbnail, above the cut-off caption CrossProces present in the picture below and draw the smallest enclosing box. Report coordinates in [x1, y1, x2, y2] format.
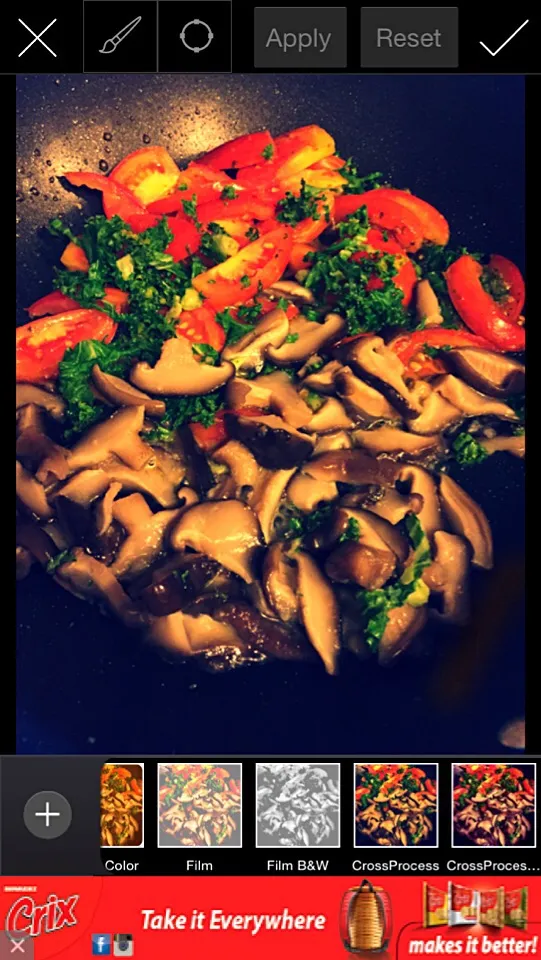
[453, 763, 536, 847]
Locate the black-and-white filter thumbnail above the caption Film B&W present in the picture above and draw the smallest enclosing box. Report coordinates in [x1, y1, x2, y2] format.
[256, 763, 340, 848]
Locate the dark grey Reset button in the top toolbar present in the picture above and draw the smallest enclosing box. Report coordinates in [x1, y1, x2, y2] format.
[361, 7, 458, 69]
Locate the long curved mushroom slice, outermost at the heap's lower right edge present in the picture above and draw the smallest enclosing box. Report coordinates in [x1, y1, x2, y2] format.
[440, 473, 493, 570]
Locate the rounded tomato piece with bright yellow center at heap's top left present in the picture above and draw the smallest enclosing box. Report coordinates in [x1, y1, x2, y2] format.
[110, 146, 180, 206]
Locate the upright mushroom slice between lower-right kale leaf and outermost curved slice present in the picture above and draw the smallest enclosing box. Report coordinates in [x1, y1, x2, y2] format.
[423, 530, 470, 624]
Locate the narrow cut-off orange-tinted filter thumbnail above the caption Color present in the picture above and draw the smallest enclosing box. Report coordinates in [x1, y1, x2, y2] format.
[100, 763, 144, 847]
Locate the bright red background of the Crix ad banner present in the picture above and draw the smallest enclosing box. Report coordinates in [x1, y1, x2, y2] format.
[0, 874, 541, 960]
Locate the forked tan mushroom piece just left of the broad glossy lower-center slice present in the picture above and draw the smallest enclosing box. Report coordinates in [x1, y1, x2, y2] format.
[110, 493, 186, 580]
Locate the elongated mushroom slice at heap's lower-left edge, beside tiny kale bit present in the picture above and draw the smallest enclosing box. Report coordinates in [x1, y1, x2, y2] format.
[56, 547, 144, 627]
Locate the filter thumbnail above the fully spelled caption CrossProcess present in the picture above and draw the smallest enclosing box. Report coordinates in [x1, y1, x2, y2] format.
[355, 763, 438, 847]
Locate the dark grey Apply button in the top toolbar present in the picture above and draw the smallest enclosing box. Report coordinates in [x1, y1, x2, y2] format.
[254, 7, 347, 70]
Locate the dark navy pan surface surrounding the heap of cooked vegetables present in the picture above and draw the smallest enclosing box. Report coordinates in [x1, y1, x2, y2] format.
[17, 75, 524, 758]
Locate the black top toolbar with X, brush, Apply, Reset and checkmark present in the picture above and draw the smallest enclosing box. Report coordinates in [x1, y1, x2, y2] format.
[3, 0, 539, 73]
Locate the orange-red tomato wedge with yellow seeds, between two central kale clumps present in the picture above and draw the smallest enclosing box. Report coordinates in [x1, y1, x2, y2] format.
[192, 227, 293, 310]
